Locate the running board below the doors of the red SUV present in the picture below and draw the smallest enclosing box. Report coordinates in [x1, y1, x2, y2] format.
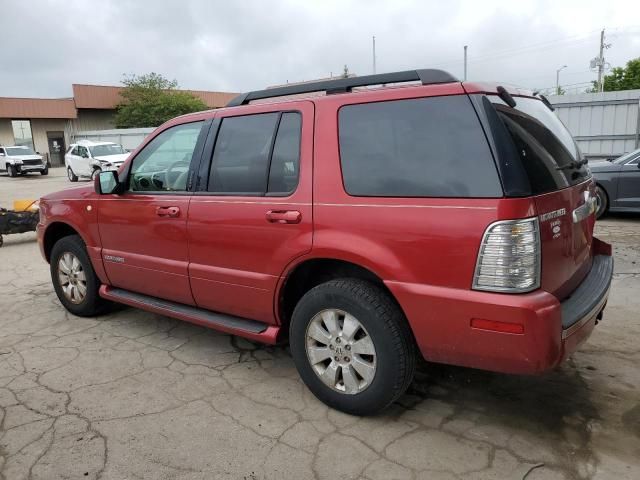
[100, 285, 280, 345]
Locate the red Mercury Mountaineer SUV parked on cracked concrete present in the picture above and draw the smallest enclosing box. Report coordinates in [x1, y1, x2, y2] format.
[38, 70, 613, 414]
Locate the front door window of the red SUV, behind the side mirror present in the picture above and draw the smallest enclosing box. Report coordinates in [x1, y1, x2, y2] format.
[129, 122, 203, 192]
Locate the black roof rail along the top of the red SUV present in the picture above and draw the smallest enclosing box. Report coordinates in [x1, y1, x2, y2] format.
[227, 69, 460, 107]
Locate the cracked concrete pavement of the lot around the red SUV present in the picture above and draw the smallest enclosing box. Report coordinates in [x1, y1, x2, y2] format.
[0, 170, 640, 480]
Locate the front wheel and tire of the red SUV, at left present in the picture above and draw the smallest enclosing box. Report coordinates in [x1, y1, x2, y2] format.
[50, 235, 108, 317]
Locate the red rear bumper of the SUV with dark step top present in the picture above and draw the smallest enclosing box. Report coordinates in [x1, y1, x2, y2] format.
[385, 239, 613, 374]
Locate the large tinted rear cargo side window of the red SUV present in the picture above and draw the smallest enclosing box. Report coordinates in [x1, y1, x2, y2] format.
[339, 95, 502, 197]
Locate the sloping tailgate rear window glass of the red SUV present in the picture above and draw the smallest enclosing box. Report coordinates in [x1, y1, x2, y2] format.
[488, 95, 590, 194]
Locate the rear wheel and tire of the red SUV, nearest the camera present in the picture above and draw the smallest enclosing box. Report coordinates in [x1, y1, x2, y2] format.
[290, 279, 416, 415]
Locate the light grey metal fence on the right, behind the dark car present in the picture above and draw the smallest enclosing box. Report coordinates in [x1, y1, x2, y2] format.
[549, 90, 640, 160]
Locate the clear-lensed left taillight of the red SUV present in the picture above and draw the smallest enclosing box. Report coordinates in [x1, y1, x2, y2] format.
[473, 218, 540, 293]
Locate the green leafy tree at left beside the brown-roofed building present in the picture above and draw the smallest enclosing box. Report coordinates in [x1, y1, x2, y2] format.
[115, 72, 208, 128]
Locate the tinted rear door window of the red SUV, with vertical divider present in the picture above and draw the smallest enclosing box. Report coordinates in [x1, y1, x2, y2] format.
[208, 112, 302, 195]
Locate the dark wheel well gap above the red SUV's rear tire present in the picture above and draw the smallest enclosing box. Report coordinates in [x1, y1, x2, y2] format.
[278, 258, 399, 326]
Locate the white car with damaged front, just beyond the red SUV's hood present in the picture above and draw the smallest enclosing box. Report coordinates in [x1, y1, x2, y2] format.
[64, 140, 129, 182]
